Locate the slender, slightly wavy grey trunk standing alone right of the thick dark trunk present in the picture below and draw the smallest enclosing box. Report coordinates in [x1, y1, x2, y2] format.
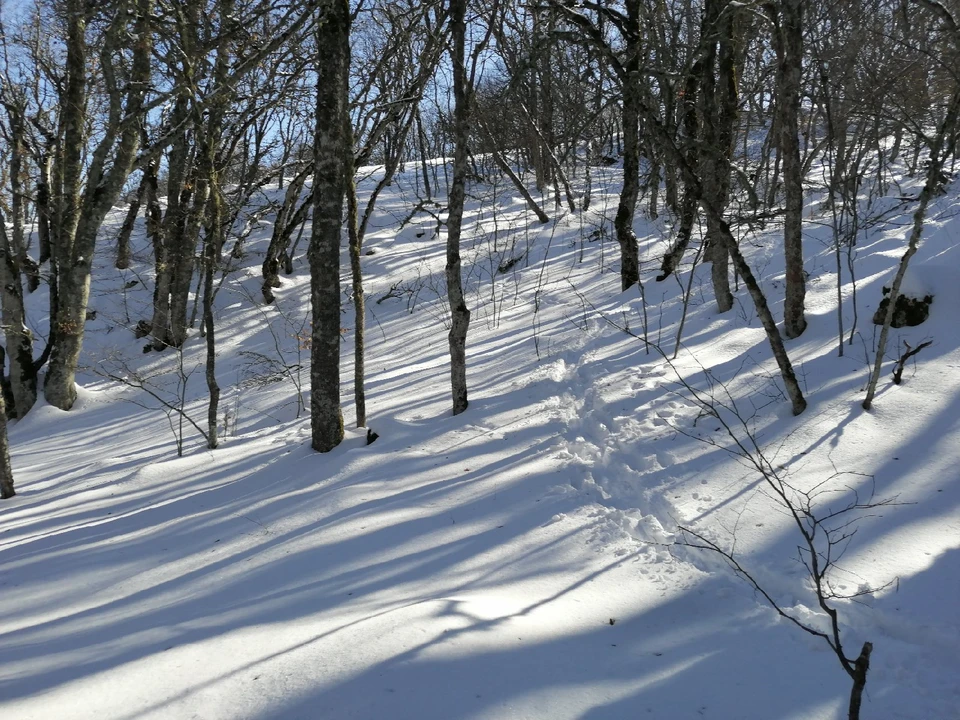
[445, 0, 472, 415]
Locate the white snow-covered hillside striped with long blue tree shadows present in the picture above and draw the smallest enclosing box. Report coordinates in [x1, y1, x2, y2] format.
[0, 160, 960, 720]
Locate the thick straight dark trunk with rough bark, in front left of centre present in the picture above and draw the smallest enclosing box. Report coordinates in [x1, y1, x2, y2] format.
[308, 0, 353, 452]
